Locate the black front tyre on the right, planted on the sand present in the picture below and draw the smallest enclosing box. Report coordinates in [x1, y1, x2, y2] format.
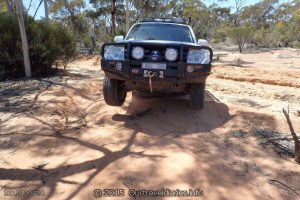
[190, 83, 205, 110]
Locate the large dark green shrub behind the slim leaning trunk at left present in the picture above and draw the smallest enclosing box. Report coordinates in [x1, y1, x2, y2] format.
[0, 14, 75, 80]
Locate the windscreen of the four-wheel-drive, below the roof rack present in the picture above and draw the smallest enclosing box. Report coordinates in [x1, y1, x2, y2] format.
[126, 23, 194, 43]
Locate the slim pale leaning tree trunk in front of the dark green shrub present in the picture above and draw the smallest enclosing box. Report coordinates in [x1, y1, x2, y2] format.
[16, 0, 31, 77]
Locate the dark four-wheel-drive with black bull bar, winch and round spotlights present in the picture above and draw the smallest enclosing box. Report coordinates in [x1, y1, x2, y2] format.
[101, 18, 213, 109]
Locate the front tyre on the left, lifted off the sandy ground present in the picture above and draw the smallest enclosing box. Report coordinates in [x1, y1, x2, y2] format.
[103, 77, 127, 106]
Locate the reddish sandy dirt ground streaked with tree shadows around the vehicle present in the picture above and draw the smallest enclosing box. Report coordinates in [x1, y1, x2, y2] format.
[0, 48, 300, 200]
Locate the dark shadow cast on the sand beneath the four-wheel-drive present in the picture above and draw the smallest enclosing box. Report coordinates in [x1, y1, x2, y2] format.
[112, 91, 234, 136]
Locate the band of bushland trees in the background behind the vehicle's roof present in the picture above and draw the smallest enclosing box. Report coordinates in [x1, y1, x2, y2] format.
[0, 0, 300, 50]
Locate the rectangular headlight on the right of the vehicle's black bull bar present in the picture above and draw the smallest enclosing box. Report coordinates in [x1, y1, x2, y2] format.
[187, 49, 211, 64]
